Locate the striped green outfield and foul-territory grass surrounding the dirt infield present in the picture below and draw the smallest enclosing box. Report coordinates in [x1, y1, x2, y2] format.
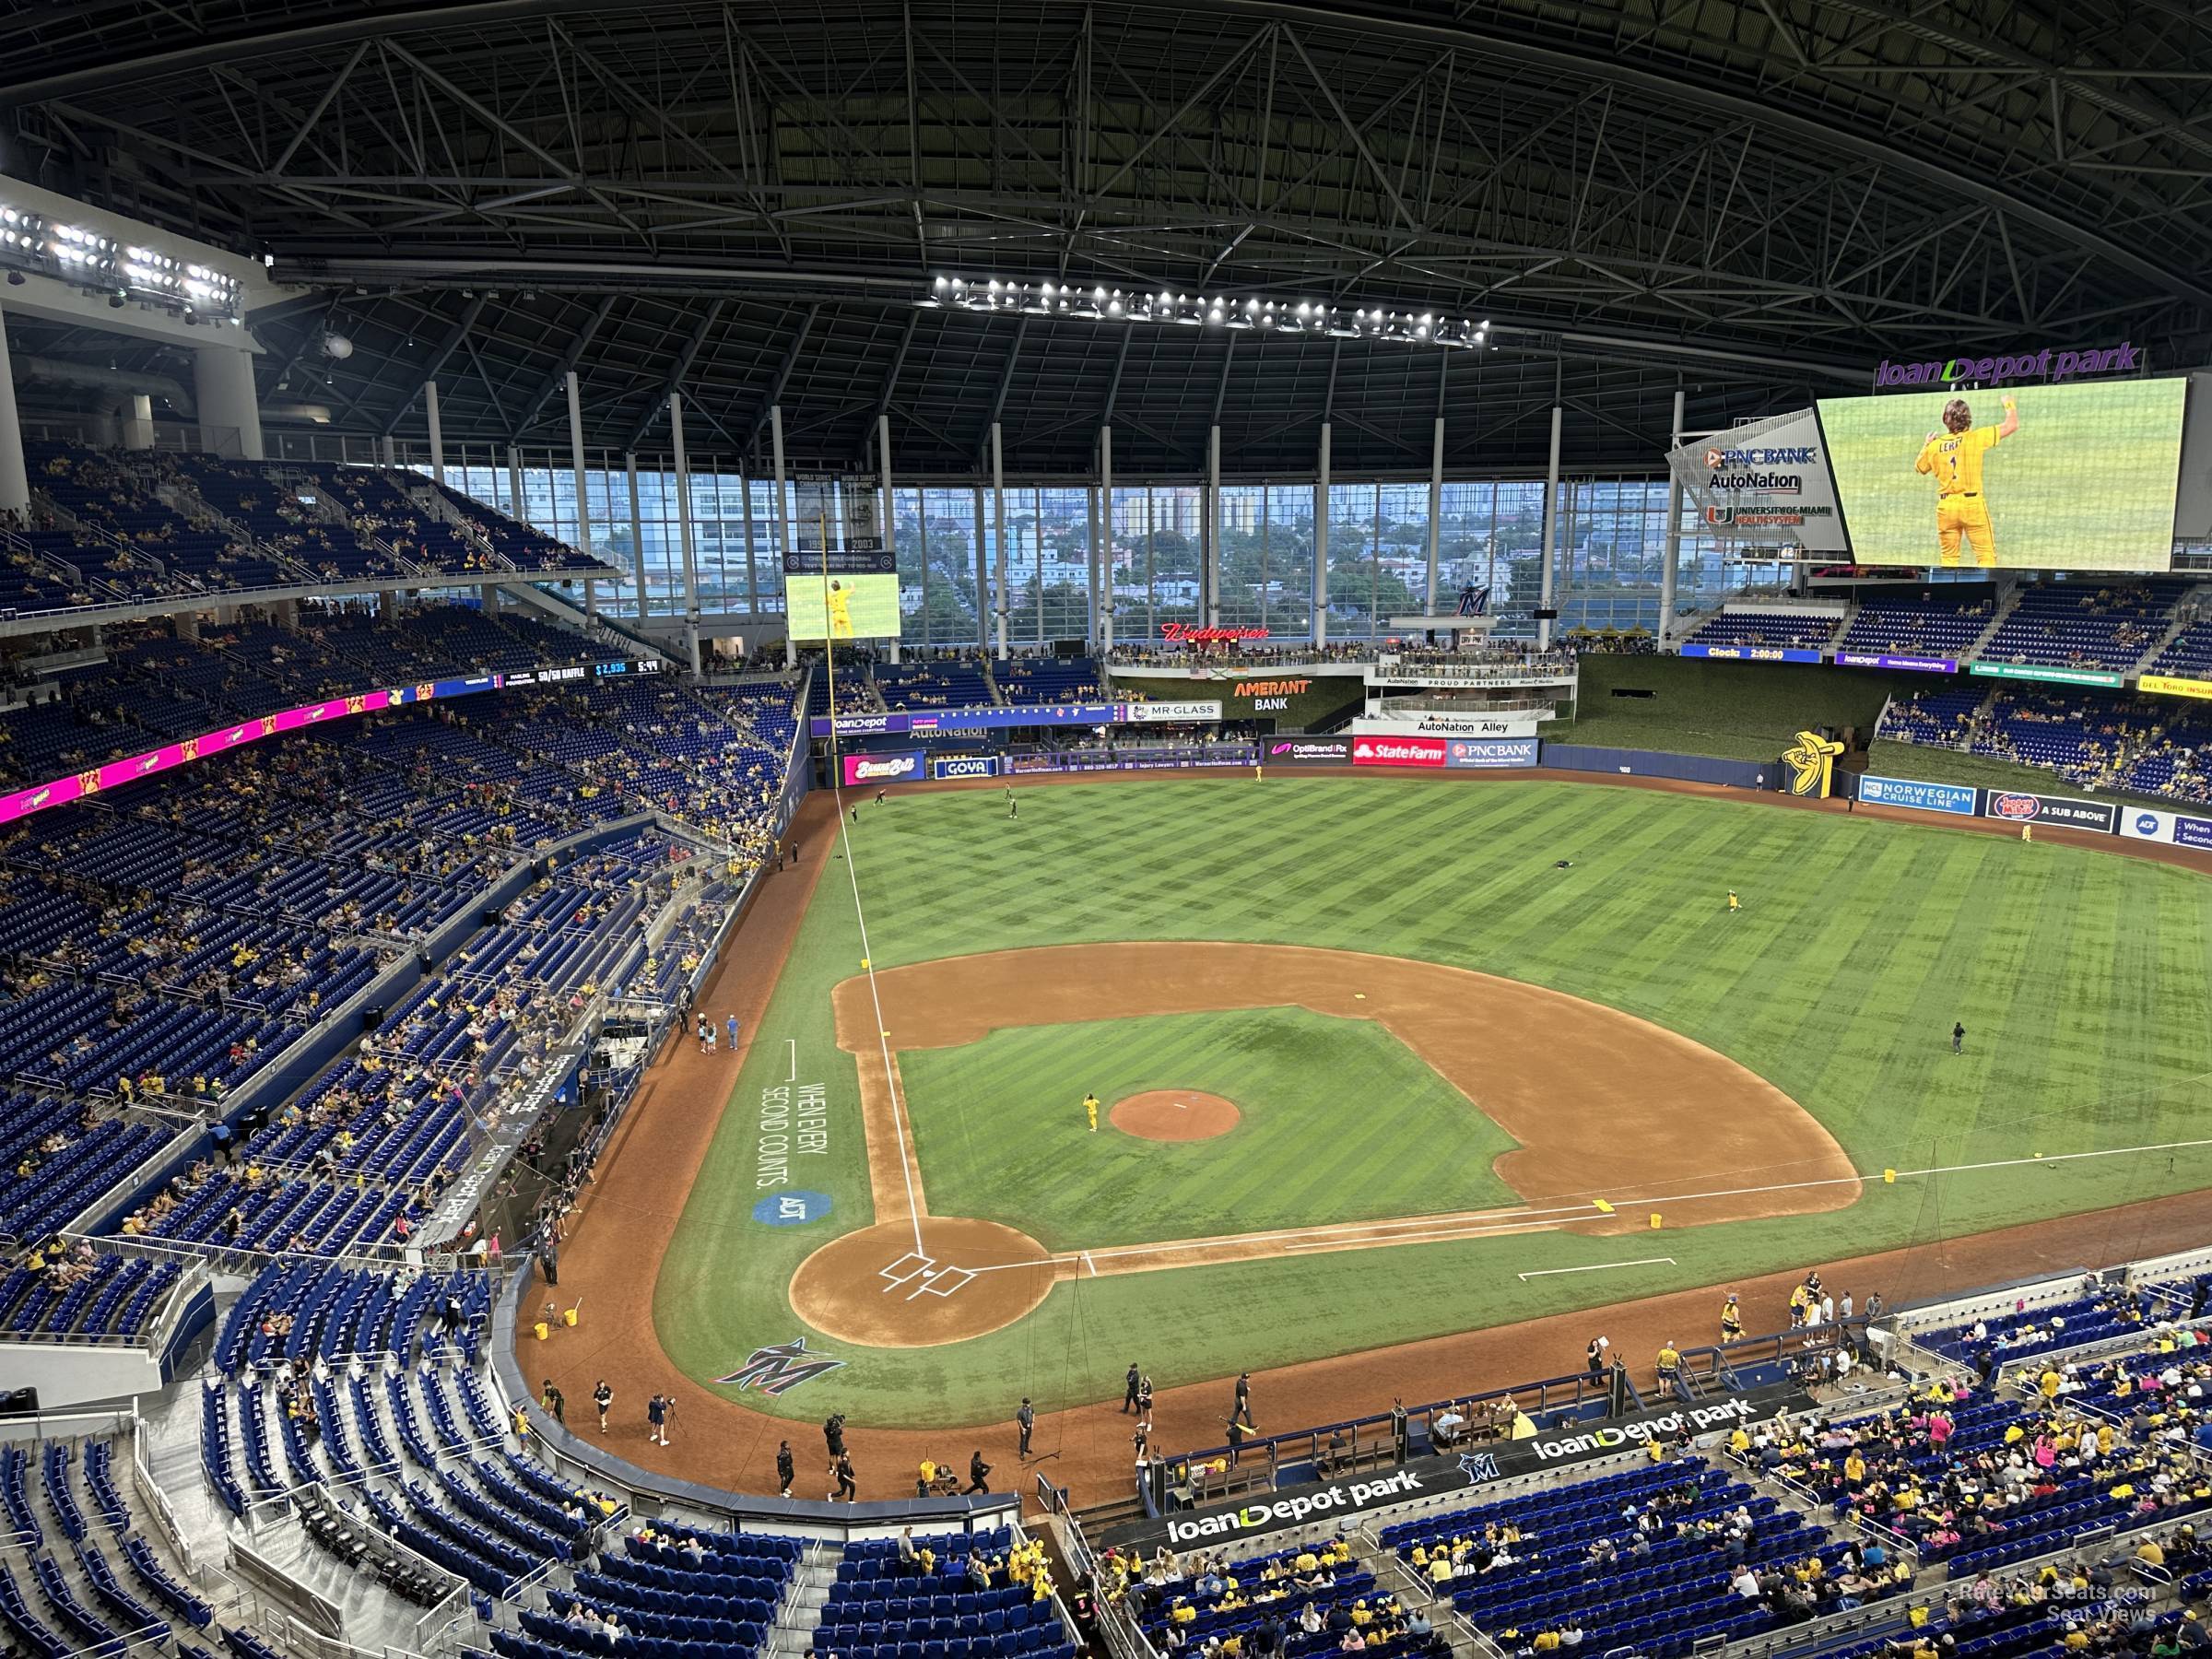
[650, 778, 2212, 1427]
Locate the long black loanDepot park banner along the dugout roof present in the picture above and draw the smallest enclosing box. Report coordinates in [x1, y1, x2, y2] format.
[1100, 1382, 1812, 1550]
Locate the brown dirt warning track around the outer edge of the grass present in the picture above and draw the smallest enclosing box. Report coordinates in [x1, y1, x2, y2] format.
[515, 770, 2212, 1504]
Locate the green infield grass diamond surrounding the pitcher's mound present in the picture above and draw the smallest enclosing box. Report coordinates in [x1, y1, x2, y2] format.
[898, 1008, 1517, 1250]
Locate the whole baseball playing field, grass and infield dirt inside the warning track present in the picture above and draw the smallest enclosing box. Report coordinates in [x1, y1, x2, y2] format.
[637, 776, 2212, 1427]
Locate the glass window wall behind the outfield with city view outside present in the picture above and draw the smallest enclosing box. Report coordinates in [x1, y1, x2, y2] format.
[422, 462, 1672, 651]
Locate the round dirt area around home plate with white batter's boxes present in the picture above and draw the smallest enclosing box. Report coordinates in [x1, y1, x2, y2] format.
[792, 1215, 1073, 1347]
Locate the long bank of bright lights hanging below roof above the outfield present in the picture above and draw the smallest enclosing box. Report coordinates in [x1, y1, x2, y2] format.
[916, 276, 1498, 352]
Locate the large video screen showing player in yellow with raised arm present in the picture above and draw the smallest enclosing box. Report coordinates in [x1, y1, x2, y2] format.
[1818, 378, 2188, 571]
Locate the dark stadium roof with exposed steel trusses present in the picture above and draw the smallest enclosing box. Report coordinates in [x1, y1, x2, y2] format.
[0, 0, 2212, 474]
